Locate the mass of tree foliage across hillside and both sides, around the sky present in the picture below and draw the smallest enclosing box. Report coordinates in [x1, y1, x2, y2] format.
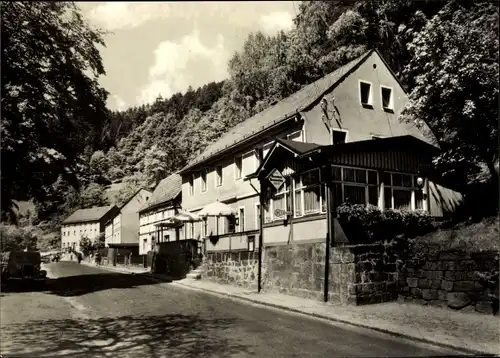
[2, 0, 498, 249]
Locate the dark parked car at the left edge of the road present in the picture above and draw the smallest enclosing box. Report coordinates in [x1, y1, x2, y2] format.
[2, 251, 47, 285]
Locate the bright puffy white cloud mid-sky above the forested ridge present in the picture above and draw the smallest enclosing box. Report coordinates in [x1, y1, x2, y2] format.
[137, 30, 230, 104]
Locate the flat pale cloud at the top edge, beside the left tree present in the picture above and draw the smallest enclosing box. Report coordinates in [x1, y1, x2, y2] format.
[88, 1, 170, 30]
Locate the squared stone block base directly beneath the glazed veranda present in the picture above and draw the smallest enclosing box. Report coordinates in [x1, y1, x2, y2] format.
[263, 243, 397, 305]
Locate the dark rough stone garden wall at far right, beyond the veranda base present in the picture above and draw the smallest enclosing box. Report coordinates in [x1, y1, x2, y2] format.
[399, 246, 498, 314]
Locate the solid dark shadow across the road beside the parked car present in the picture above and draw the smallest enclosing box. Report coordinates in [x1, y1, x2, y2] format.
[2, 272, 171, 297]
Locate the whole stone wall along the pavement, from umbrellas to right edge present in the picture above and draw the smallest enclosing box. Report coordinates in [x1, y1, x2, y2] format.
[199, 242, 498, 313]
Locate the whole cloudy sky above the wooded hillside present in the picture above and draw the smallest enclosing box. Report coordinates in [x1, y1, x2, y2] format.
[78, 1, 298, 110]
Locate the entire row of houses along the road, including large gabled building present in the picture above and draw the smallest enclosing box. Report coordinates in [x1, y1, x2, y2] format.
[61, 50, 462, 255]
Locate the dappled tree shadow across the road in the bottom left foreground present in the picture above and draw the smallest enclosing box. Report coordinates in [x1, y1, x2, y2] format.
[1, 314, 254, 357]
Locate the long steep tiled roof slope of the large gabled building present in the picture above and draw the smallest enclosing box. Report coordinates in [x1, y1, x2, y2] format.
[181, 50, 373, 172]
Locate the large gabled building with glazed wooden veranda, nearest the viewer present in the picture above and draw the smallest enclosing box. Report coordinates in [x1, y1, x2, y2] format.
[180, 50, 460, 251]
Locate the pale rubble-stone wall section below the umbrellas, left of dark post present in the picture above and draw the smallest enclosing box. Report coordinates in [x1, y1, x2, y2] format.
[202, 251, 258, 288]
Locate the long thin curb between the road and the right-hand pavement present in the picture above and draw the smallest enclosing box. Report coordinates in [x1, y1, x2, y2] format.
[159, 277, 497, 357]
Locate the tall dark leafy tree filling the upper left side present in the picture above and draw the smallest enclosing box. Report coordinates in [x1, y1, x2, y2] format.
[0, 2, 107, 219]
